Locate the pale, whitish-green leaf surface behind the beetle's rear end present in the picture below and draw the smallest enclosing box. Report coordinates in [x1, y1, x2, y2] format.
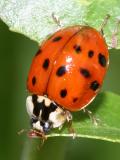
[0, 0, 120, 48]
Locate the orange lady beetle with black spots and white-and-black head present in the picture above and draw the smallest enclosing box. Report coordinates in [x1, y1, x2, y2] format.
[26, 16, 109, 136]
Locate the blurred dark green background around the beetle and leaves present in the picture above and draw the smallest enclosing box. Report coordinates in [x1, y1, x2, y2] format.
[0, 21, 120, 160]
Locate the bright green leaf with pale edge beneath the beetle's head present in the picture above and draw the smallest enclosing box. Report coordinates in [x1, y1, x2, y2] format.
[43, 92, 120, 143]
